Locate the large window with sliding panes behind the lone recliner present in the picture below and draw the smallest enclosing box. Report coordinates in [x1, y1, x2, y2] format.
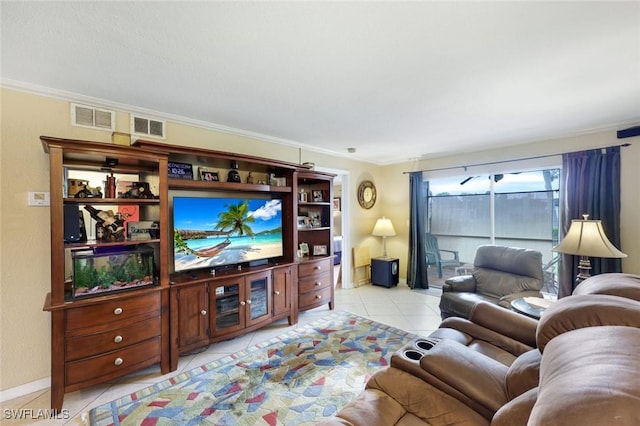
[427, 169, 560, 293]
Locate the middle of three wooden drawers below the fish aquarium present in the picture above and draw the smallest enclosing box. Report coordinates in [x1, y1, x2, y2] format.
[65, 318, 161, 361]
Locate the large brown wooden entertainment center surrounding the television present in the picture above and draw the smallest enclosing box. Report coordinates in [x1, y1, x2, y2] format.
[41, 136, 334, 410]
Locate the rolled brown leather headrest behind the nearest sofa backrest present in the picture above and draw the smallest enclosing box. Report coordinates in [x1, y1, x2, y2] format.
[536, 294, 640, 353]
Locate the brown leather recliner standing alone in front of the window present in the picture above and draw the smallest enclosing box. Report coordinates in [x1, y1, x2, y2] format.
[440, 245, 544, 319]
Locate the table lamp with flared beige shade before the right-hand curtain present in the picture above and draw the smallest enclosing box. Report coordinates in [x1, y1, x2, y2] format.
[551, 214, 627, 284]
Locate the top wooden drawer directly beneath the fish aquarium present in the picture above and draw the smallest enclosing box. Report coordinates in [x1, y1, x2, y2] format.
[65, 292, 161, 330]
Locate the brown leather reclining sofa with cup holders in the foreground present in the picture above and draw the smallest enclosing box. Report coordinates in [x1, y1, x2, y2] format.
[320, 274, 640, 426]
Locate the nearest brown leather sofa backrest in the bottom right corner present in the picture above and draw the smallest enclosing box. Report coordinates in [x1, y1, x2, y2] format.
[528, 324, 640, 426]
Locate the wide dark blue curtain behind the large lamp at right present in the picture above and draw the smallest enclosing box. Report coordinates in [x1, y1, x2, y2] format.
[558, 146, 622, 297]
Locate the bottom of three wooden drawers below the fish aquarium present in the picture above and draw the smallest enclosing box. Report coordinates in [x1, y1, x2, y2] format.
[65, 336, 160, 386]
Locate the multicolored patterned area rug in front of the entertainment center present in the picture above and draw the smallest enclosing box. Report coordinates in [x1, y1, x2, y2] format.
[90, 312, 417, 426]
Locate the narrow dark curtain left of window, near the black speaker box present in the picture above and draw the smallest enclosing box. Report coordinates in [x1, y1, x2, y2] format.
[407, 172, 429, 288]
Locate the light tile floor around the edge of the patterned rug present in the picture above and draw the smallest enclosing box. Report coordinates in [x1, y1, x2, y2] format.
[0, 284, 441, 425]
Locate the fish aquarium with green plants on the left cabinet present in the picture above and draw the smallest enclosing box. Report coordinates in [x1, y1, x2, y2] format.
[71, 247, 158, 299]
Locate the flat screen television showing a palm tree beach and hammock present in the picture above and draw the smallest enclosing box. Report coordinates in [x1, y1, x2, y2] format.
[173, 197, 283, 272]
